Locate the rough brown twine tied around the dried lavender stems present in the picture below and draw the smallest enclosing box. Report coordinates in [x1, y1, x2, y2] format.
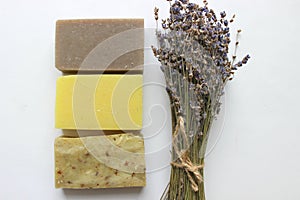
[171, 116, 204, 192]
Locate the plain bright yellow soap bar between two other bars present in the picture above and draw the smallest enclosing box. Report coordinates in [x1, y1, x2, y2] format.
[55, 74, 143, 130]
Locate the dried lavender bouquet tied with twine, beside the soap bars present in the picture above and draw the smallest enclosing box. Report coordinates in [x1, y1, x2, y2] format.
[152, 0, 250, 200]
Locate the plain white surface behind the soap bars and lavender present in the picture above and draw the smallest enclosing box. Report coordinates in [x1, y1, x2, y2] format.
[0, 0, 300, 200]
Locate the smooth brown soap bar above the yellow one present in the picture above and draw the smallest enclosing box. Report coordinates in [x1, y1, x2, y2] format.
[55, 19, 144, 73]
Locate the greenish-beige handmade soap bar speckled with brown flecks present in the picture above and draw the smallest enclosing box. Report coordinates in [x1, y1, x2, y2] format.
[55, 134, 146, 189]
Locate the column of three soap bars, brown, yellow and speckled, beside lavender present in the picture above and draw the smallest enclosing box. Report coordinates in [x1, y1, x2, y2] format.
[55, 19, 145, 189]
